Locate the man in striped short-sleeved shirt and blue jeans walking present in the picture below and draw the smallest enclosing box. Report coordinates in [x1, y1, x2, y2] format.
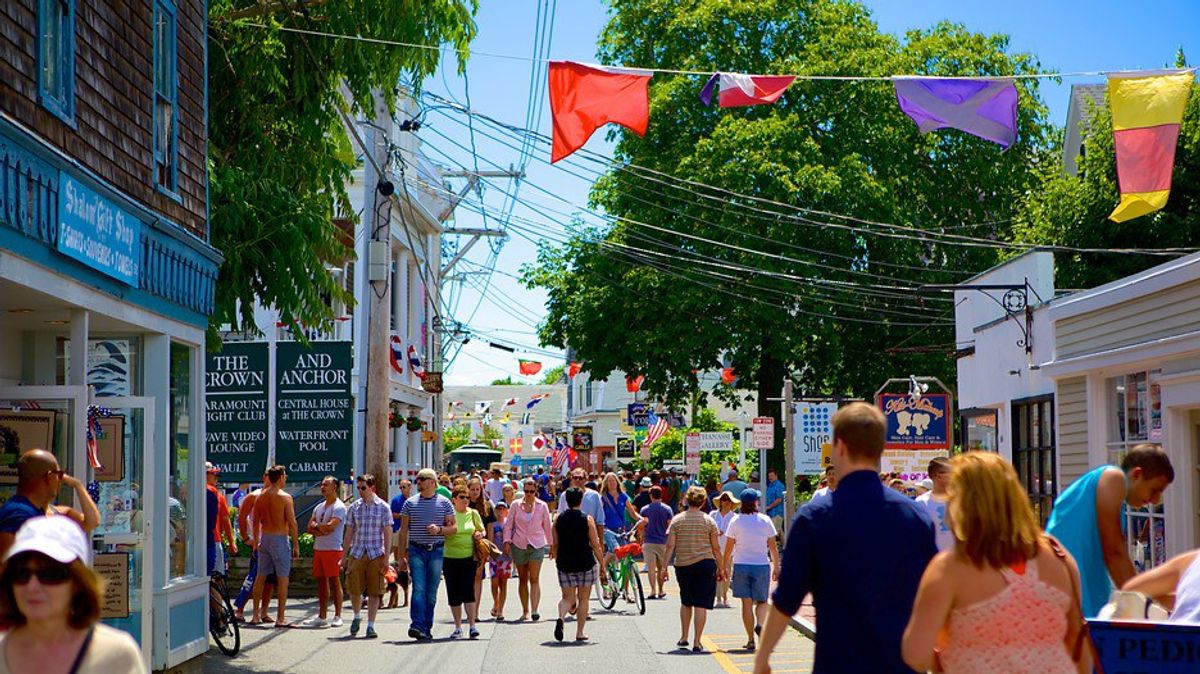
[396, 468, 458, 640]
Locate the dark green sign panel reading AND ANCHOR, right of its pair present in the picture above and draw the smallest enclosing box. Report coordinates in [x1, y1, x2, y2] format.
[275, 342, 354, 482]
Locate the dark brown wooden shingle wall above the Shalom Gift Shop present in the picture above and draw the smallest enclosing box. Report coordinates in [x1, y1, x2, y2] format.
[0, 0, 208, 239]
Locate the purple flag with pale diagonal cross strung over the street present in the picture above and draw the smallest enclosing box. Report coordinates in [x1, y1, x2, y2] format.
[892, 77, 1016, 150]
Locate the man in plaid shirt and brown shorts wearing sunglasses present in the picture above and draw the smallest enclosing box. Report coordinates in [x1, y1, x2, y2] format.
[342, 473, 391, 639]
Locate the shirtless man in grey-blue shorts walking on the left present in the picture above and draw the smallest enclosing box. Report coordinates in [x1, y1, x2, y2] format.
[250, 465, 300, 627]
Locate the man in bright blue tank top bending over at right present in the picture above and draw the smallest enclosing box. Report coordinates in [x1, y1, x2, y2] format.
[1046, 444, 1175, 618]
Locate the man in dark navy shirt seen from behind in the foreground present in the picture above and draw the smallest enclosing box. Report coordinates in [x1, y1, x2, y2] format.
[755, 403, 937, 674]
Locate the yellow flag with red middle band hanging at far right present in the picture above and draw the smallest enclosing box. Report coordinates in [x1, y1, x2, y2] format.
[1109, 71, 1195, 222]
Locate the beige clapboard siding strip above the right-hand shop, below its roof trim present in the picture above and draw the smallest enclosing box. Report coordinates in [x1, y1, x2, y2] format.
[1055, 281, 1200, 359]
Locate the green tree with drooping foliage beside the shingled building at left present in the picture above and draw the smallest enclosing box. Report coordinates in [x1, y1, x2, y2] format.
[208, 0, 476, 333]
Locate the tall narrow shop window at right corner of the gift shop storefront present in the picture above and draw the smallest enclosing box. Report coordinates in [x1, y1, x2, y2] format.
[166, 342, 194, 578]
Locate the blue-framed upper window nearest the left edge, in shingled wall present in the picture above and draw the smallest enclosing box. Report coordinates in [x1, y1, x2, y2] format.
[37, 0, 74, 124]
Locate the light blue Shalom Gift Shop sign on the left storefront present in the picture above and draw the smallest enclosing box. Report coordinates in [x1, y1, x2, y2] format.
[59, 173, 142, 287]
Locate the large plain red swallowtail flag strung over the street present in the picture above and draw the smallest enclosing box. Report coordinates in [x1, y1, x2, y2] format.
[548, 61, 650, 163]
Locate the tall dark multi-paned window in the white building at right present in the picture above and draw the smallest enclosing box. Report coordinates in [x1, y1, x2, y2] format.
[1012, 396, 1058, 526]
